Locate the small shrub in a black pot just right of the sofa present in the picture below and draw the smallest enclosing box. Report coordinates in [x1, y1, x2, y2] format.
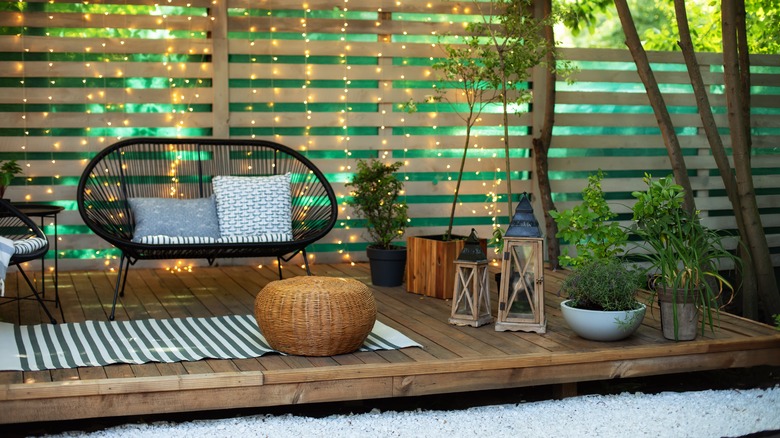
[346, 159, 409, 286]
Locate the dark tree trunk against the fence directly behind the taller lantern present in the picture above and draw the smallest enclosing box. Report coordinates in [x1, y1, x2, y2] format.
[531, 0, 561, 269]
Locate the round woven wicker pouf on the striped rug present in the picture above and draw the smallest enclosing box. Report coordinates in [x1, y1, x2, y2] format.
[255, 276, 376, 356]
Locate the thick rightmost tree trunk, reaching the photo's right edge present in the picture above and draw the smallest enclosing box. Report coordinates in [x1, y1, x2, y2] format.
[721, 0, 780, 320]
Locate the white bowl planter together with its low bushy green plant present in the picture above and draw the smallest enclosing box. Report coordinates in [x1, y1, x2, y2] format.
[561, 257, 647, 341]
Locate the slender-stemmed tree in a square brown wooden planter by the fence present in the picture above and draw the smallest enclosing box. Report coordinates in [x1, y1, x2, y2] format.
[407, 0, 554, 298]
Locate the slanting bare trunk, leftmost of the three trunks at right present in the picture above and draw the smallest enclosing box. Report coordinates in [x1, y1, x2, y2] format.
[614, 0, 696, 216]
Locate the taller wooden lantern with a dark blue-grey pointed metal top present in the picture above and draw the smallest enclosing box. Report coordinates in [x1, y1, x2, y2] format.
[496, 193, 547, 333]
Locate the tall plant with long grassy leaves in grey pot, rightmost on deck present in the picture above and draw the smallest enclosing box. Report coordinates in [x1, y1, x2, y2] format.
[632, 174, 740, 341]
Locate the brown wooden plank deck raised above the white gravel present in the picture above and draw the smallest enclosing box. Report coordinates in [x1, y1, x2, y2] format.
[0, 264, 780, 423]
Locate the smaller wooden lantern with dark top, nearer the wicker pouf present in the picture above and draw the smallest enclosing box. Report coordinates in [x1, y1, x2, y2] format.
[449, 229, 493, 327]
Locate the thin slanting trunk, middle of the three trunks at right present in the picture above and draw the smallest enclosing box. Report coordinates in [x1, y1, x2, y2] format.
[674, 0, 758, 320]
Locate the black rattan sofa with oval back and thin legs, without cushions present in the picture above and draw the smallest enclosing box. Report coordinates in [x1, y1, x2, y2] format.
[77, 138, 338, 320]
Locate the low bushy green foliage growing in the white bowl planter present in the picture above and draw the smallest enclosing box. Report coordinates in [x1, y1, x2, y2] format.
[561, 257, 643, 311]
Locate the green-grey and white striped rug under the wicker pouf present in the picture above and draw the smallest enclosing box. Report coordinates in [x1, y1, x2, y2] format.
[0, 315, 421, 371]
